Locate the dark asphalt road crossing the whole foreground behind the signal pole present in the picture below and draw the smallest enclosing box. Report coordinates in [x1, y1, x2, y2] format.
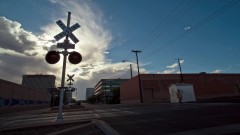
[0, 103, 240, 135]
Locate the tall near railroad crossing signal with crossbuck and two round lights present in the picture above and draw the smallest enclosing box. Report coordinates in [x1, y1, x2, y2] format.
[50, 12, 82, 123]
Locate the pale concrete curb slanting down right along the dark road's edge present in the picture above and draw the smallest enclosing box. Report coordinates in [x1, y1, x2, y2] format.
[93, 120, 120, 135]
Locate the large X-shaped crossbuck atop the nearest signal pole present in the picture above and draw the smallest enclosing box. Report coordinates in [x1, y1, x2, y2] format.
[54, 20, 80, 44]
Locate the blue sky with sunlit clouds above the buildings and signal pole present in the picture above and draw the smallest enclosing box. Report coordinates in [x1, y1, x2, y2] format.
[0, 0, 240, 99]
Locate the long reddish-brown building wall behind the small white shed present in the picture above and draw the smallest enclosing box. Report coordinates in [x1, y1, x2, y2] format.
[120, 74, 240, 103]
